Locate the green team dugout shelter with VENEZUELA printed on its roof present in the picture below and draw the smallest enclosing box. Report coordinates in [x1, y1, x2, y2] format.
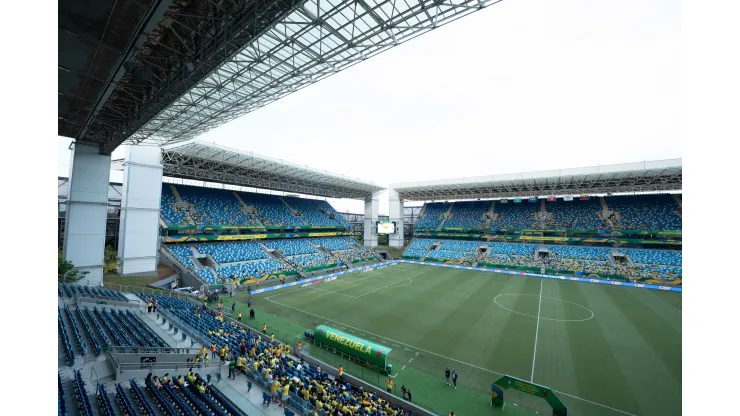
[313, 325, 391, 370]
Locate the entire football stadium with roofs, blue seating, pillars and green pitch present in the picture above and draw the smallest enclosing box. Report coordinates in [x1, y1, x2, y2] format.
[57, 0, 683, 416]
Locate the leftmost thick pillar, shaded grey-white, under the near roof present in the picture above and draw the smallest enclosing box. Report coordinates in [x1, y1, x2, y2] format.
[63, 143, 110, 284]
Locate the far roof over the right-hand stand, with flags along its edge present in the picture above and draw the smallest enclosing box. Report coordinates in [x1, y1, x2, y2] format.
[390, 159, 682, 201]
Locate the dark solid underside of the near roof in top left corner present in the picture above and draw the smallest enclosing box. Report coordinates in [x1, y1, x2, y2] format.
[57, 0, 171, 143]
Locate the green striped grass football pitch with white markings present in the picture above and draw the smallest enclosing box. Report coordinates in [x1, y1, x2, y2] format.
[249, 264, 681, 416]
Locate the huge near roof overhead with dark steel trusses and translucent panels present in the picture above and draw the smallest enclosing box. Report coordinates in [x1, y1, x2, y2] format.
[59, 0, 501, 154]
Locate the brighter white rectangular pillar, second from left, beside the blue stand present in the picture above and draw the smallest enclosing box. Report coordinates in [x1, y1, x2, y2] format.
[118, 146, 162, 275]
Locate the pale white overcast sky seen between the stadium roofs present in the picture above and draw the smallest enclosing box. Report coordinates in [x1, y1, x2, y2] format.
[58, 0, 682, 214]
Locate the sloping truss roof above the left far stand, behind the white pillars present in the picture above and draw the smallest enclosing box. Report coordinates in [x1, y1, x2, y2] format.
[162, 141, 385, 199]
